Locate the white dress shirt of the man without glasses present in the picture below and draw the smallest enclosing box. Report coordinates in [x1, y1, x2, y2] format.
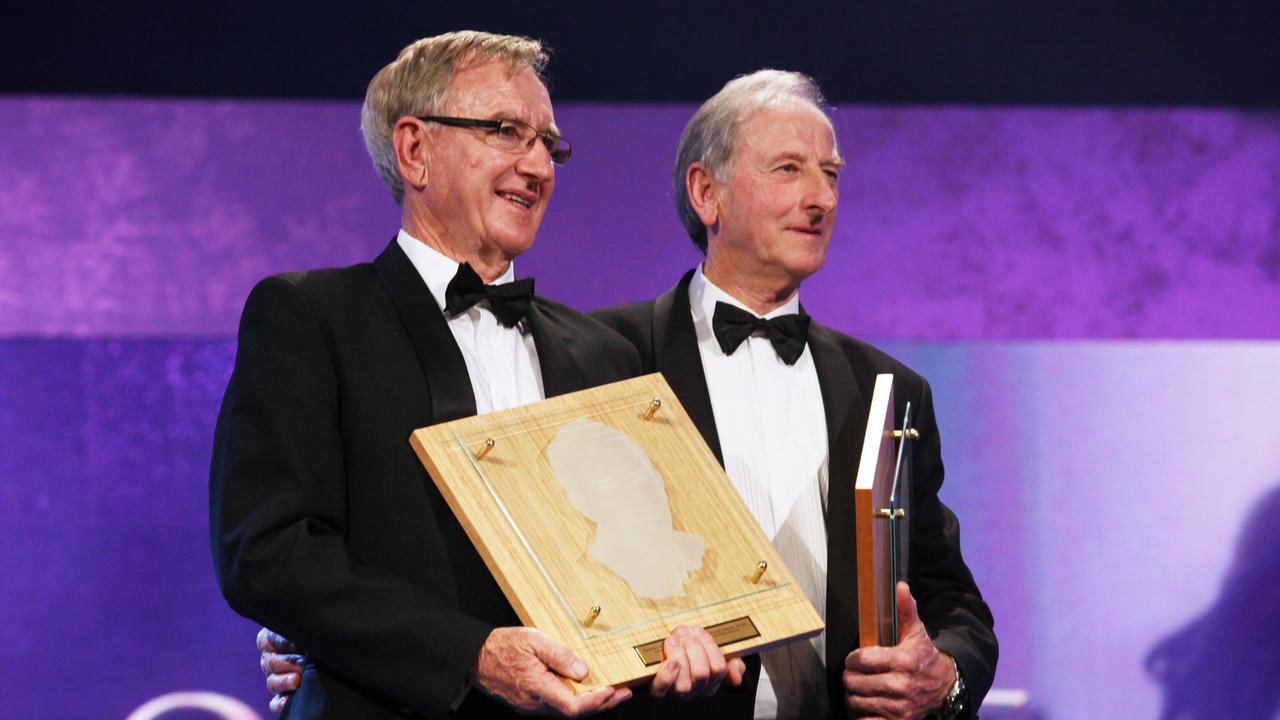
[689, 266, 828, 719]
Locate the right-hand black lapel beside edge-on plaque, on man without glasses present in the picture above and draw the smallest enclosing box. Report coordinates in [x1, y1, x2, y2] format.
[809, 319, 867, 667]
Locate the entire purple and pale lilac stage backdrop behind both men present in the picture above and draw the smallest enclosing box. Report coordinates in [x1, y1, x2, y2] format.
[0, 97, 1280, 719]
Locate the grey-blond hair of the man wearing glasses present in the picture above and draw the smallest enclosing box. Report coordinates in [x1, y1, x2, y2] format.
[360, 29, 548, 205]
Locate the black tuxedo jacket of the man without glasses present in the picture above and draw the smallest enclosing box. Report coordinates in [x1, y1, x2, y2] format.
[593, 270, 997, 720]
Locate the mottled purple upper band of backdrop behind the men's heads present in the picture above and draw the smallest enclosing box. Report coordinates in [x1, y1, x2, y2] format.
[0, 100, 1280, 340]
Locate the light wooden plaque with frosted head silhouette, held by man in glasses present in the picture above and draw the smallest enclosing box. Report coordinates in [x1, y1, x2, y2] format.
[410, 373, 823, 692]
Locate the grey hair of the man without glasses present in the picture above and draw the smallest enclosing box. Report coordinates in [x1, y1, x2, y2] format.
[671, 69, 829, 255]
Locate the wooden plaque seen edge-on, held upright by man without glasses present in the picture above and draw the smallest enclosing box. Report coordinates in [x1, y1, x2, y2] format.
[854, 374, 914, 647]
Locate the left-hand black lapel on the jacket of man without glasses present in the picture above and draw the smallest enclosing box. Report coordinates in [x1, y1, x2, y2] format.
[653, 270, 724, 466]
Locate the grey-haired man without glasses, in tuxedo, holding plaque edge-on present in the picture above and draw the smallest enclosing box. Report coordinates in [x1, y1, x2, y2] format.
[594, 70, 997, 719]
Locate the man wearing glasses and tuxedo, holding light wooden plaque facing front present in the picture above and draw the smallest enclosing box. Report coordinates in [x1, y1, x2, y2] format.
[210, 32, 744, 719]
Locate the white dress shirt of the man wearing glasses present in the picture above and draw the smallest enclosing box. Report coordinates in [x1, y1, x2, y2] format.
[396, 229, 545, 414]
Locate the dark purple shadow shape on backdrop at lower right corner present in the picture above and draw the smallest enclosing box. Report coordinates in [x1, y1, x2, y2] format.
[1147, 486, 1280, 720]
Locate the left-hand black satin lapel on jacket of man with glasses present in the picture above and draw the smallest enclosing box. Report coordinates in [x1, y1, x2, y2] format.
[374, 240, 476, 424]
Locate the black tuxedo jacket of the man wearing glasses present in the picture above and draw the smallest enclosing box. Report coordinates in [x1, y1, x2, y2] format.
[210, 241, 639, 719]
